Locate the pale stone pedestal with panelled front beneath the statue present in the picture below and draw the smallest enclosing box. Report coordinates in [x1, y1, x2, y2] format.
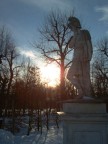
[62, 99, 108, 144]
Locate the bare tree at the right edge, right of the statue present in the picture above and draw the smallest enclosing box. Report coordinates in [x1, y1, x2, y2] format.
[94, 37, 108, 97]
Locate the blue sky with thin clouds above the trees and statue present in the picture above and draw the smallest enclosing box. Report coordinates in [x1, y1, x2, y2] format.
[0, 0, 108, 54]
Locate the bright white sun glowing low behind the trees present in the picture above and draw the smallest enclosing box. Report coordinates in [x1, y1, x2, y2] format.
[40, 64, 60, 87]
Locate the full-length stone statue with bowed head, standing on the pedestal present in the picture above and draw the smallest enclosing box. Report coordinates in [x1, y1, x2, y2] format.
[67, 17, 93, 99]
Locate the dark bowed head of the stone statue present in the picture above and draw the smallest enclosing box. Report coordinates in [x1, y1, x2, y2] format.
[68, 17, 81, 28]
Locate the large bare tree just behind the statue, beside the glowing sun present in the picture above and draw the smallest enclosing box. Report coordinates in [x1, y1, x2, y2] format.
[34, 11, 72, 98]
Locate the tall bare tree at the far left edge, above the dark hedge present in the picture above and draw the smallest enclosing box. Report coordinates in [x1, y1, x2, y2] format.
[0, 27, 19, 94]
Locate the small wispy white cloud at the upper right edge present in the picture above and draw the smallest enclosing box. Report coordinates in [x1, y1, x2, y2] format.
[96, 6, 108, 21]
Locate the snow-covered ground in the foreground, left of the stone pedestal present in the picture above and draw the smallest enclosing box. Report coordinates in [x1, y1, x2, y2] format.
[0, 121, 63, 144]
